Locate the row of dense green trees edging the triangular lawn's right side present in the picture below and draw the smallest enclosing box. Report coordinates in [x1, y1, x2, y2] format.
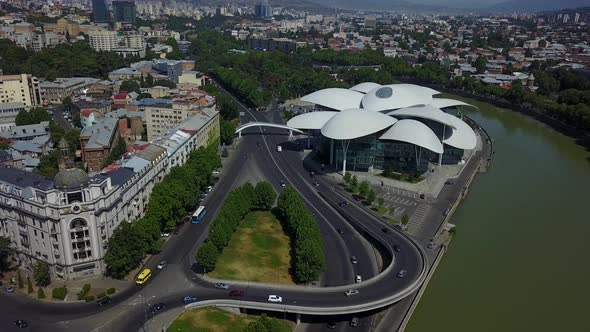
[277, 186, 326, 283]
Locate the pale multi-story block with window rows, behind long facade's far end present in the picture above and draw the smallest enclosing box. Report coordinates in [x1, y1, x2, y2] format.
[143, 95, 215, 140]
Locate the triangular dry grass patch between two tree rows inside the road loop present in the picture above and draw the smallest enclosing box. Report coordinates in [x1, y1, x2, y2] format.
[209, 211, 295, 285]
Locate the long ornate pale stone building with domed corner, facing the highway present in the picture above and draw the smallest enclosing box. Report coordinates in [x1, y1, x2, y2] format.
[0, 105, 219, 280]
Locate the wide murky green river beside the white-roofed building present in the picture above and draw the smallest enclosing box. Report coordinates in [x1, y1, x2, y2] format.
[406, 97, 590, 332]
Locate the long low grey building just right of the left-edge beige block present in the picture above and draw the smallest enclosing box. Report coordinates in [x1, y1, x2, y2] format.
[39, 77, 100, 104]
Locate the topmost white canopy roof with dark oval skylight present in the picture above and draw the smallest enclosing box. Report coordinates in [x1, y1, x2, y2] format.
[362, 84, 438, 112]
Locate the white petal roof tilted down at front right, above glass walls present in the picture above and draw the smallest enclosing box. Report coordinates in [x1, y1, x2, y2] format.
[379, 119, 443, 153]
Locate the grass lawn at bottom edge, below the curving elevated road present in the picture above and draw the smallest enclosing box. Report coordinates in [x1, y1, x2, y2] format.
[168, 308, 293, 332]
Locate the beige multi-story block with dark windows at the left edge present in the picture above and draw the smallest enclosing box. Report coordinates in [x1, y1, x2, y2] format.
[0, 74, 41, 107]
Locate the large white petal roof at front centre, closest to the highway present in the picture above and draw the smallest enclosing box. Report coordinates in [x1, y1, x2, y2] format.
[322, 108, 397, 140]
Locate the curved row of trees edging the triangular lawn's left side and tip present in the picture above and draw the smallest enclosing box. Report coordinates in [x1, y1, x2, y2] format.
[195, 181, 277, 272]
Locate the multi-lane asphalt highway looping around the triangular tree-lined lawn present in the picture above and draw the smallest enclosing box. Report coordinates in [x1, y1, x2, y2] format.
[0, 83, 427, 331]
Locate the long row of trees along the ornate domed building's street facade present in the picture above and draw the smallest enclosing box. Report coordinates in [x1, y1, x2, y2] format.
[105, 144, 221, 278]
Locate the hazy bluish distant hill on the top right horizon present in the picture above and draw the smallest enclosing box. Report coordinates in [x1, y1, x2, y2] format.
[484, 0, 589, 13]
